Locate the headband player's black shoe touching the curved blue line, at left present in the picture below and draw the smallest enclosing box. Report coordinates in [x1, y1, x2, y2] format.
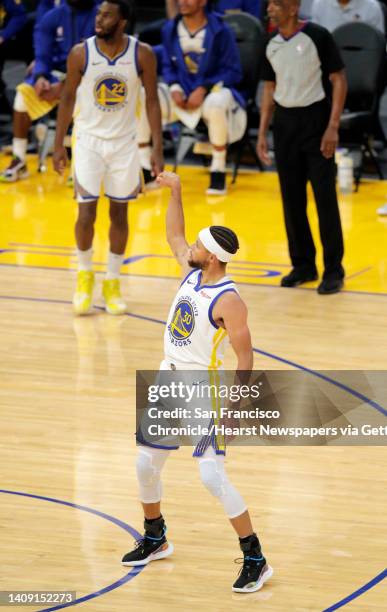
[121, 517, 173, 567]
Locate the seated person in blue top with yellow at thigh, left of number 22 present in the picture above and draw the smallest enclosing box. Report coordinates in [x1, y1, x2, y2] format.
[0, 0, 96, 183]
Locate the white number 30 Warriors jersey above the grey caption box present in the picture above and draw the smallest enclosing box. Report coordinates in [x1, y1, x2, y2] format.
[164, 270, 238, 369]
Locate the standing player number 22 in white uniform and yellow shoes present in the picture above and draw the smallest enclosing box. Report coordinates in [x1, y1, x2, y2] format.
[54, 0, 163, 315]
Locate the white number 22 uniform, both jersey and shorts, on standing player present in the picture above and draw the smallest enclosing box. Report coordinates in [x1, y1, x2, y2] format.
[73, 36, 141, 202]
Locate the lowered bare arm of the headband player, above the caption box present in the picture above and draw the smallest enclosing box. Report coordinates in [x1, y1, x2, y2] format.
[212, 291, 254, 372]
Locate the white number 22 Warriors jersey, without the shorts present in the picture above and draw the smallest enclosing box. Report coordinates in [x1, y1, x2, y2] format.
[74, 36, 140, 140]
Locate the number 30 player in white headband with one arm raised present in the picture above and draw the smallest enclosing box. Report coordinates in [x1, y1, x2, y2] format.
[122, 172, 273, 593]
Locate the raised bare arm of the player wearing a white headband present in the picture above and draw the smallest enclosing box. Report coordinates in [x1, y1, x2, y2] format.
[157, 172, 189, 274]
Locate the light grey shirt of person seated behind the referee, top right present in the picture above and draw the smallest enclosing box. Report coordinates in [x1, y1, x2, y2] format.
[311, 0, 384, 34]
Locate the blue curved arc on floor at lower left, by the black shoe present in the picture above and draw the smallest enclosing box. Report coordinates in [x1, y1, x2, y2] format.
[0, 489, 146, 612]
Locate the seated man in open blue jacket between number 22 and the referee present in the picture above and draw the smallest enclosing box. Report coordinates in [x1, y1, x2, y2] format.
[138, 0, 246, 195]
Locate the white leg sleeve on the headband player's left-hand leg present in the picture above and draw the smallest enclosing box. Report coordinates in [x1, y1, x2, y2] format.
[136, 448, 168, 504]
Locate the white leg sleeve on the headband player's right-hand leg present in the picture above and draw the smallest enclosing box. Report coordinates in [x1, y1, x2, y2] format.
[199, 458, 247, 518]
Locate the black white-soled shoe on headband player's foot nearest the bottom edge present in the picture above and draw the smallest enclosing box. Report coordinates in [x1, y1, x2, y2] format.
[232, 533, 273, 593]
